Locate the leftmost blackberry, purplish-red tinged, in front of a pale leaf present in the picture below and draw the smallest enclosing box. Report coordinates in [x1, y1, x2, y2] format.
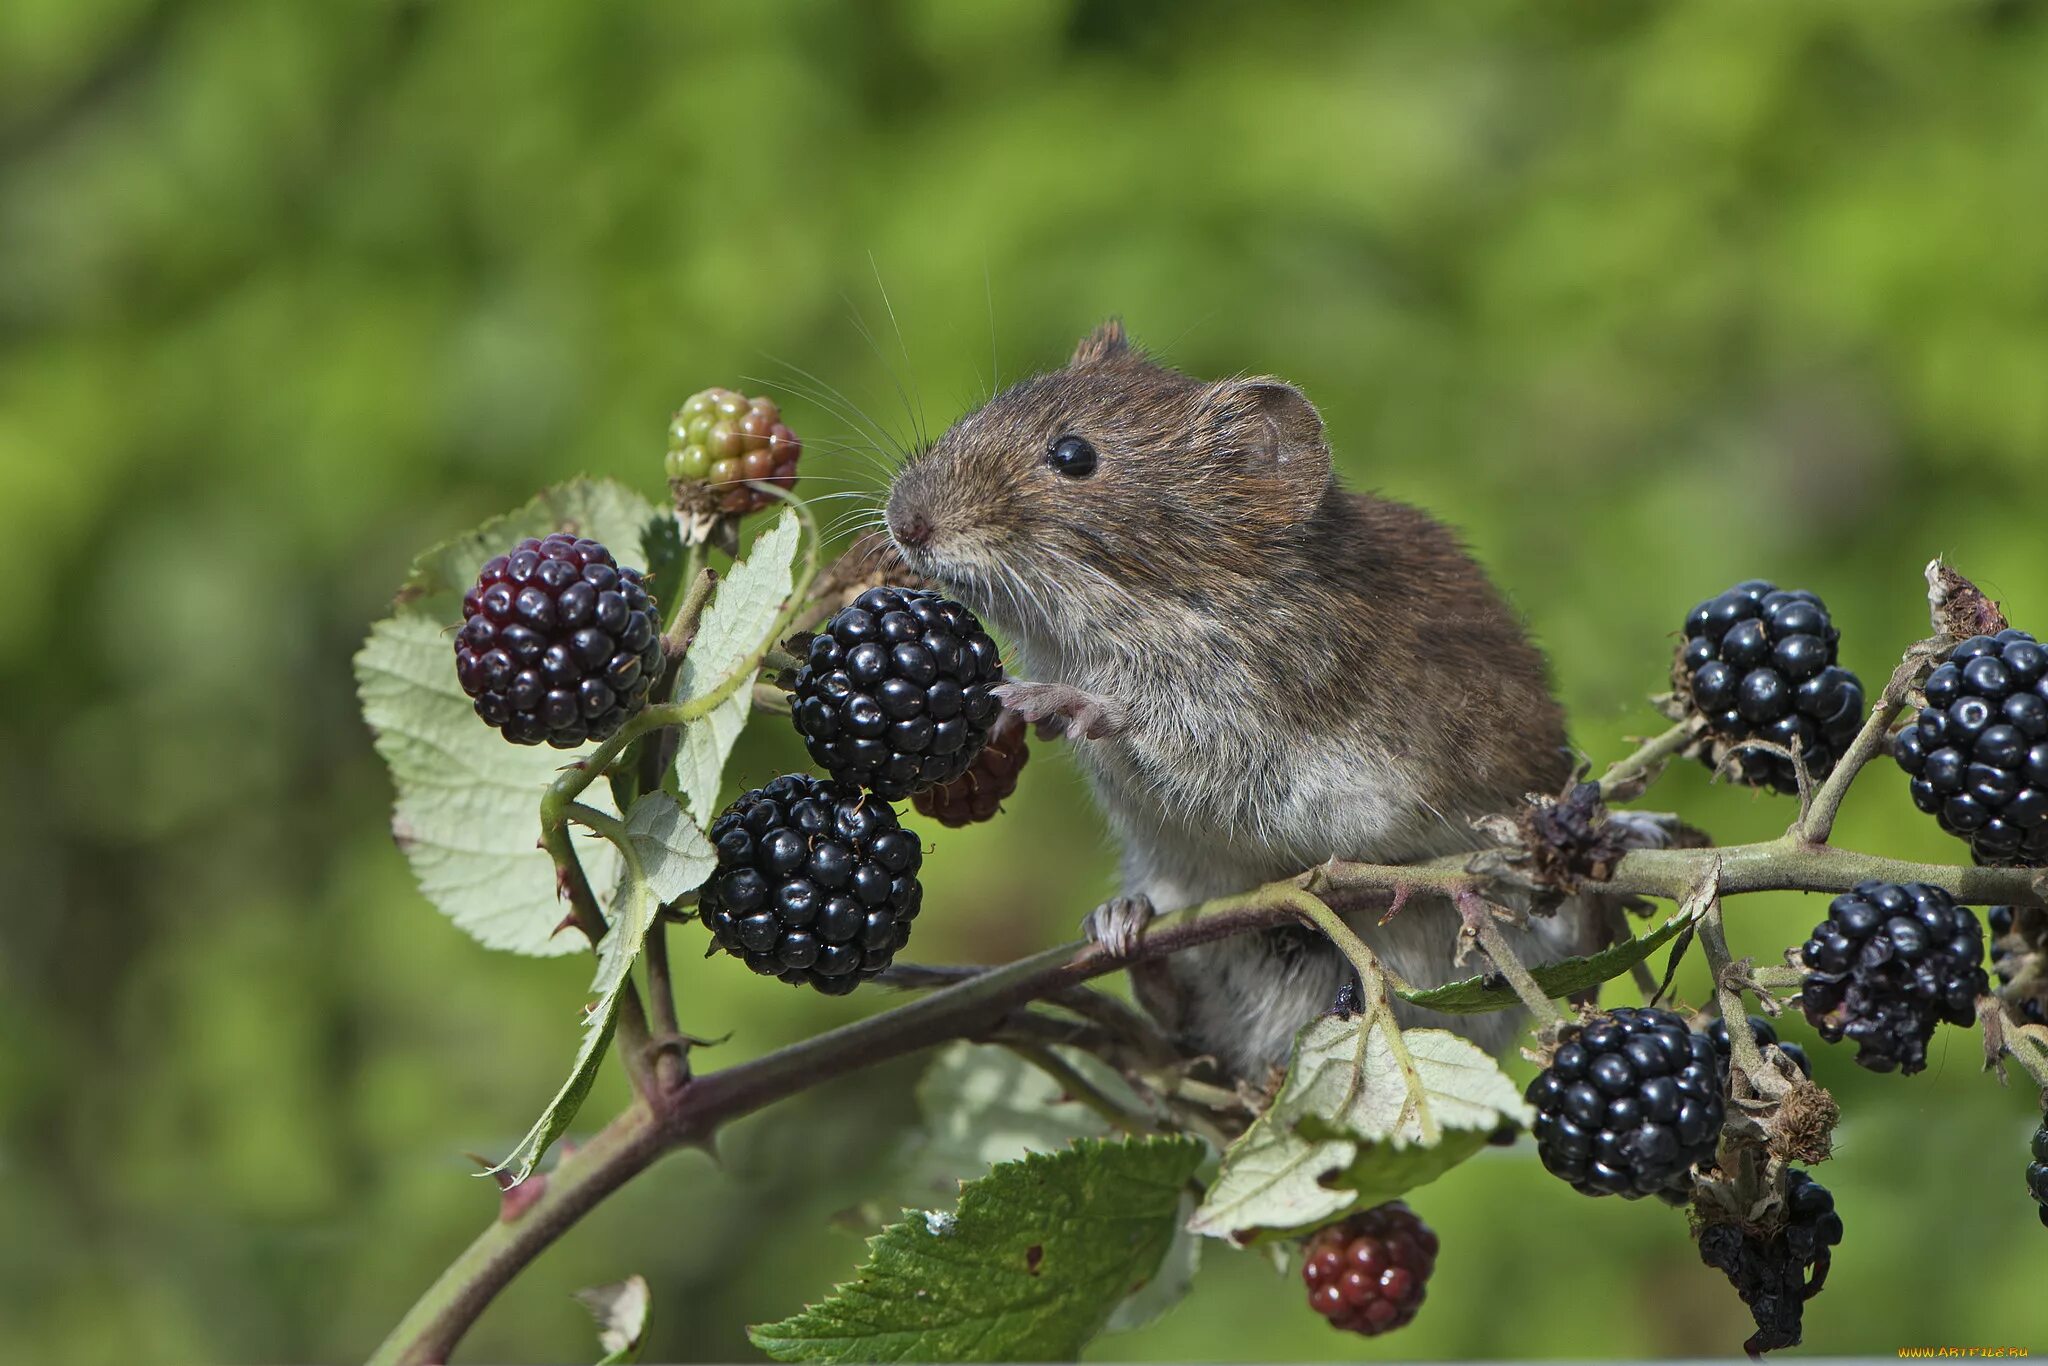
[455, 532, 662, 750]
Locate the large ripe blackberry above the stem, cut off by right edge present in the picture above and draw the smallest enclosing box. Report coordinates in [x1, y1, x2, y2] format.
[1892, 631, 2048, 866]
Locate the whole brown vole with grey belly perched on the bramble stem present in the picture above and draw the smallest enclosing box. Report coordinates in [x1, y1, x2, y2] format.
[885, 319, 1597, 1079]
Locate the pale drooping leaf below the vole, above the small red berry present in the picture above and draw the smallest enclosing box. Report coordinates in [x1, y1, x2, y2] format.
[1190, 1006, 1530, 1243]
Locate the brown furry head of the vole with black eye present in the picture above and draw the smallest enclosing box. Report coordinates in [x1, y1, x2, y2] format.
[889, 322, 1331, 643]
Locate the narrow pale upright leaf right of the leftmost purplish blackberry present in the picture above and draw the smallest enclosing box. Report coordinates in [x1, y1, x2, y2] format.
[676, 508, 801, 825]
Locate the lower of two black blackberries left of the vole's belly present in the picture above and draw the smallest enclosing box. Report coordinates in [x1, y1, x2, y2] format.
[696, 774, 924, 995]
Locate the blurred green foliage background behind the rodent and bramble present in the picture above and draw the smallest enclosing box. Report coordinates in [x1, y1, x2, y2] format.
[0, 0, 2048, 1362]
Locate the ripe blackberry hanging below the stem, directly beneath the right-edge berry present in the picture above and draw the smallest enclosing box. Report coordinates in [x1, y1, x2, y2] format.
[1800, 883, 1991, 1073]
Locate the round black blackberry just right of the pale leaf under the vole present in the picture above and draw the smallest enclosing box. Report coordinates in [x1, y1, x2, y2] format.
[1528, 1006, 1724, 1200]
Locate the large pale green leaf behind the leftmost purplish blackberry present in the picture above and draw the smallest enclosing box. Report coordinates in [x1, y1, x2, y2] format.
[354, 481, 662, 954]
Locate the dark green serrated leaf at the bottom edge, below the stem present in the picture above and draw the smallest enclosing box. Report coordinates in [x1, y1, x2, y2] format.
[748, 1139, 1204, 1362]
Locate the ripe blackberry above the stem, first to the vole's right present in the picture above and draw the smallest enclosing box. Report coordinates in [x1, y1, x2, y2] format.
[1675, 580, 1864, 793]
